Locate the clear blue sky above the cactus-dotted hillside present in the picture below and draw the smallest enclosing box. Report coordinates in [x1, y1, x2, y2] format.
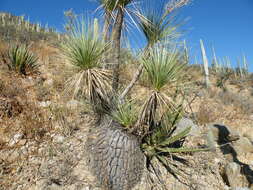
[0, 0, 253, 72]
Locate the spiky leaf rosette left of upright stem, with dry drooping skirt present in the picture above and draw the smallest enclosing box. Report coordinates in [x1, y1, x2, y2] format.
[61, 19, 111, 111]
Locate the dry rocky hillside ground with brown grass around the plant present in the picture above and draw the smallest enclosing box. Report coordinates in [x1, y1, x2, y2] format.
[0, 17, 253, 190]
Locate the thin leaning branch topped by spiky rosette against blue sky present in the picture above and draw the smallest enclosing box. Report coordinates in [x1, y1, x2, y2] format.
[120, 0, 189, 101]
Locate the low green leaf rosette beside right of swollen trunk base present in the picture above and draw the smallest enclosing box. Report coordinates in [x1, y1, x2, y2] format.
[141, 105, 209, 176]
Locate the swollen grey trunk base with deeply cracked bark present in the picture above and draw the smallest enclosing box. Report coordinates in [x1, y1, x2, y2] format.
[87, 118, 145, 190]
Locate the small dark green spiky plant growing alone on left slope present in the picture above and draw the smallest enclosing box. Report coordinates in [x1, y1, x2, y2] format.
[1, 45, 39, 75]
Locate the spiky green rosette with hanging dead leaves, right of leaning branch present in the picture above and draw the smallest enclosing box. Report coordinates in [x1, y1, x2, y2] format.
[139, 45, 185, 125]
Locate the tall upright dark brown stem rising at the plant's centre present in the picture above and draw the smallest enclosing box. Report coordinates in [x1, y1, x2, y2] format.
[112, 7, 124, 91]
